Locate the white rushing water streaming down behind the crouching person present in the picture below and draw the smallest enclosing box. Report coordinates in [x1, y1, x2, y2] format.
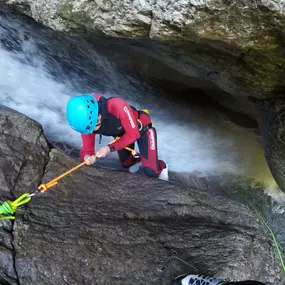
[0, 8, 278, 186]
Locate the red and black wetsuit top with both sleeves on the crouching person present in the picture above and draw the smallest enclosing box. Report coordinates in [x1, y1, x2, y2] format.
[80, 94, 140, 161]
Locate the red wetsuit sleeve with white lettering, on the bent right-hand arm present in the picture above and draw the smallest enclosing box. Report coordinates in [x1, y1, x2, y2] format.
[108, 98, 140, 151]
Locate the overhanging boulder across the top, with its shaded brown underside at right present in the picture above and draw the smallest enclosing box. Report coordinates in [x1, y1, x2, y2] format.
[0, 0, 285, 98]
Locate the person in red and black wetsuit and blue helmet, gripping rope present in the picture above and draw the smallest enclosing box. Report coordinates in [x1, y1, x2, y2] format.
[66, 94, 168, 180]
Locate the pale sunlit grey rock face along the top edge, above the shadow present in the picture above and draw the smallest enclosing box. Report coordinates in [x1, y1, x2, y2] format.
[1, 0, 285, 42]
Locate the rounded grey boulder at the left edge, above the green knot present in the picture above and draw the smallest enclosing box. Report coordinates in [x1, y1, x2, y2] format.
[0, 106, 49, 195]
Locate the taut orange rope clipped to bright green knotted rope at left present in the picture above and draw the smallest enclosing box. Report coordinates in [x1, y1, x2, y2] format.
[0, 162, 86, 221]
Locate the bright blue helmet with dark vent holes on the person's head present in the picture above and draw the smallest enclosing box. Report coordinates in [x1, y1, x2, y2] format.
[66, 94, 98, 134]
